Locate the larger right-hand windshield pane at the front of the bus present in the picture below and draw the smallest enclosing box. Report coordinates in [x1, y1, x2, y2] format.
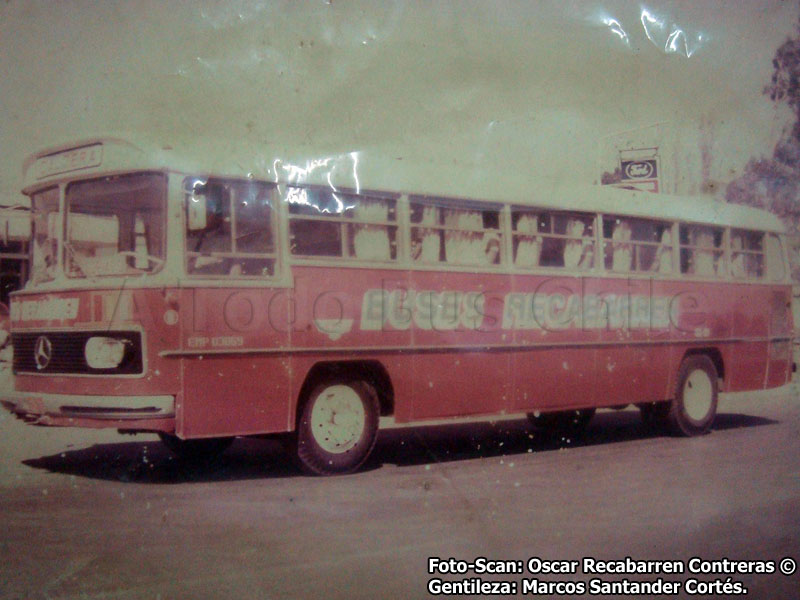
[64, 173, 166, 277]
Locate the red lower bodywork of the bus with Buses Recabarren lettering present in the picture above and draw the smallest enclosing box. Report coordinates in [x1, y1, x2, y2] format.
[7, 265, 792, 438]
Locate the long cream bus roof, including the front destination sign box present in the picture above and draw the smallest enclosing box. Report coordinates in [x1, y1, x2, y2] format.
[24, 137, 784, 232]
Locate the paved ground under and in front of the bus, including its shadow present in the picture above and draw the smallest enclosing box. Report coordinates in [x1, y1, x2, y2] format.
[0, 387, 800, 598]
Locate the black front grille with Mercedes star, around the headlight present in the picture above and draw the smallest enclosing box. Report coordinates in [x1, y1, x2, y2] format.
[11, 331, 143, 375]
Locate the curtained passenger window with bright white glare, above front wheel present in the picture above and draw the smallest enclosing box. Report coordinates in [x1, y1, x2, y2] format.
[285, 187, 397, 262]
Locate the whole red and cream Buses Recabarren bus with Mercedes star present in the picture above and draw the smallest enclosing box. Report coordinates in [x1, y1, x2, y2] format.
[2, 138, 793, 474]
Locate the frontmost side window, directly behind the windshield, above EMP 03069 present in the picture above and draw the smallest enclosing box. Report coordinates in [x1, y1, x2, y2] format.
[186, 179, 276, 277]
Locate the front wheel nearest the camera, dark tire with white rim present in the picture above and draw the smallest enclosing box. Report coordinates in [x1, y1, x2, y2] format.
[296, 378, 380, 475]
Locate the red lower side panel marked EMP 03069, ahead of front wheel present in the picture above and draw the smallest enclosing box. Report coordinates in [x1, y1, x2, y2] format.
[177, 287, 292, 437]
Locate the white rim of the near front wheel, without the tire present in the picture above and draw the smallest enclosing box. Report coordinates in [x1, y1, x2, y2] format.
[311, 385, 367, 454]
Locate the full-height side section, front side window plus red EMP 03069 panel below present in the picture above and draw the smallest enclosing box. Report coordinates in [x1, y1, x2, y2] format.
[177, 178, 292, 437]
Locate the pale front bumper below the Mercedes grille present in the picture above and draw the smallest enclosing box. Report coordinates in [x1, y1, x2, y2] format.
[0, 391, 175, 421]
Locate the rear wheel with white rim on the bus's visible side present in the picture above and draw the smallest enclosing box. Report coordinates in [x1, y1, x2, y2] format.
[666, 354, 717, 437]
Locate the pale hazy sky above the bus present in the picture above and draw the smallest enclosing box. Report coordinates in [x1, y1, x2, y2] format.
[0, 0, 798, 204]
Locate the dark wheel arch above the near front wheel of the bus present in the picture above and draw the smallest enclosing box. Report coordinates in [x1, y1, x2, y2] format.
[292, 360, 394, 429]
